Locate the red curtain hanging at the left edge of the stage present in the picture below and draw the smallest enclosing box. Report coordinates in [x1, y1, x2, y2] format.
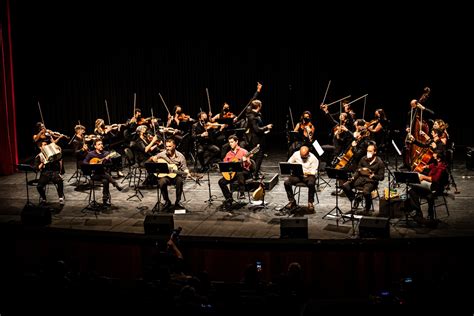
[0, 0, 18, 175]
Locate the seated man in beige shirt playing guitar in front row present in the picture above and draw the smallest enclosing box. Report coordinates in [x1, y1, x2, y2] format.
[151, 138, 189, 210]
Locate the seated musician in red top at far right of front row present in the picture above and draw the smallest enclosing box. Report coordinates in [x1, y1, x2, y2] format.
[408, 152, 449, 220]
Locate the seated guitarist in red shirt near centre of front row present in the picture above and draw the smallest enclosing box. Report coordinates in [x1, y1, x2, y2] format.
[219, 135, 252, 210]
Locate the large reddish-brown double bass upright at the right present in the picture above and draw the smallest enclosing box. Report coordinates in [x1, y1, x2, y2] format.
[404, 87, 433, 172]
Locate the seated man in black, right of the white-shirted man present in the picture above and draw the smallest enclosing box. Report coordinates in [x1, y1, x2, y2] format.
[342, 143, 385, 215]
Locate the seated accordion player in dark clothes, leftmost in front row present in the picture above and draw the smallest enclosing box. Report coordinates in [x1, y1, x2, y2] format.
[35, 141, 64, 205]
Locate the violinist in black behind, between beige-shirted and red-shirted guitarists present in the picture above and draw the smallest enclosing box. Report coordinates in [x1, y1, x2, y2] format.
[192, 112, 220, 172]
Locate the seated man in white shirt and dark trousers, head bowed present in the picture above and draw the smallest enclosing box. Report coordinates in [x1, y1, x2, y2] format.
[284, 146, 319, 213]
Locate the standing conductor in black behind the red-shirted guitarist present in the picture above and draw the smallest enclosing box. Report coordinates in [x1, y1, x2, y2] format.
[247, 100, 273, 179]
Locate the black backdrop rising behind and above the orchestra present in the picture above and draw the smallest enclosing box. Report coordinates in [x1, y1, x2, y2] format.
[12, 3, 474, 157]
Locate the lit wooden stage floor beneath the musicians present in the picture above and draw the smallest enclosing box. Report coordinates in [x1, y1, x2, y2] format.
[0, 152, 474, 239]
